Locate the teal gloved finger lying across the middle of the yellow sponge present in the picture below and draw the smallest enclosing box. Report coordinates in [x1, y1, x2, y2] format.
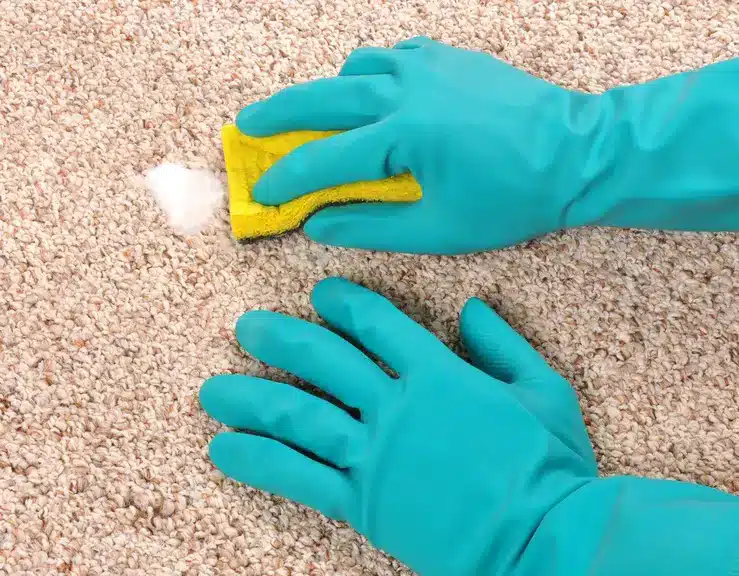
[253, 122, 406, 206]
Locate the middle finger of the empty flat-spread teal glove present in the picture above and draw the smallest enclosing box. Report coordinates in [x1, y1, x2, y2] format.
[236, 310, 390, 415]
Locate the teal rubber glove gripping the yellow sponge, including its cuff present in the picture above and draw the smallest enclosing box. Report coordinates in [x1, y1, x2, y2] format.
[236, 38, 739, 254]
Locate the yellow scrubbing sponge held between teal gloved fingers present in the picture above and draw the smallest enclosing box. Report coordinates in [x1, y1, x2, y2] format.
[221, 124, 421, 241]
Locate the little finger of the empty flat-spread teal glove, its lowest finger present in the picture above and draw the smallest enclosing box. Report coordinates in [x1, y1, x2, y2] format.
[209, 432, 350, 521]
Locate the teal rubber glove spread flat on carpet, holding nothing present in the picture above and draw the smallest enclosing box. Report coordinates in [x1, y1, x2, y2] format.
[200, 278, 739, 576]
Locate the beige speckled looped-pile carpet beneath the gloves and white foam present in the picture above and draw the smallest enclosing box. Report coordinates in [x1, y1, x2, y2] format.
[0, 0, 739, 576]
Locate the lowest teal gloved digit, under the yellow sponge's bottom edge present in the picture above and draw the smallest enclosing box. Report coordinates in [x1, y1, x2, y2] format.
[303, 202, 434, 253]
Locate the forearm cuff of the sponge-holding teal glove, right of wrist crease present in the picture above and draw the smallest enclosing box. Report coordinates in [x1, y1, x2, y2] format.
[565, 58, 739, 232]
